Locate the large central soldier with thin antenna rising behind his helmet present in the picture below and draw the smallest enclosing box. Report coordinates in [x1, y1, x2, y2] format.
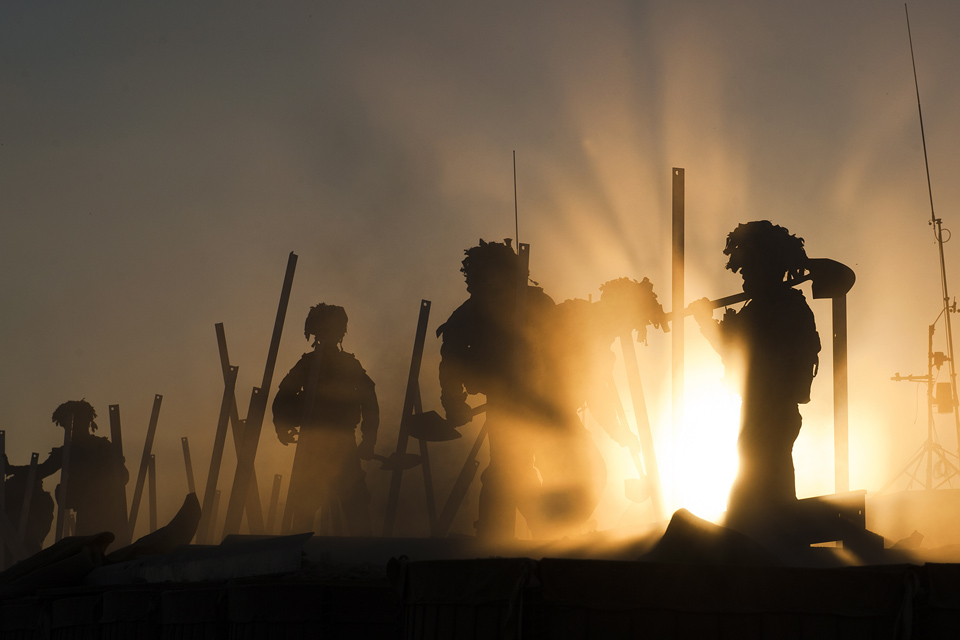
[437, 240, 603, 539]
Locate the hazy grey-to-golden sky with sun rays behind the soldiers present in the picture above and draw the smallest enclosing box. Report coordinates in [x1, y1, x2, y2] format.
[0, 0, 960, 534]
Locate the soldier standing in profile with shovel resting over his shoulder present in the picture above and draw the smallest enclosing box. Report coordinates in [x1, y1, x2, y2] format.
[694, 220, 820, 528]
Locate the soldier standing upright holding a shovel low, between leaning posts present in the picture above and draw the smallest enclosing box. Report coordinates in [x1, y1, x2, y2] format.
[273, 302, 380, 536]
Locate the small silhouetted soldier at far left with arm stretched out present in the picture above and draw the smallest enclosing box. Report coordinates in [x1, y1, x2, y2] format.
[7, 400, 130, 540]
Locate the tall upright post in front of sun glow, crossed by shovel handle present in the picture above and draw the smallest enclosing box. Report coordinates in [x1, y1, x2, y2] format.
[670, 167, 686, 510]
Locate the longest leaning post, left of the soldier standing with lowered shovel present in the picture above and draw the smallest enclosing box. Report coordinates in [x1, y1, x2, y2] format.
[223, 252, 297, 535]
